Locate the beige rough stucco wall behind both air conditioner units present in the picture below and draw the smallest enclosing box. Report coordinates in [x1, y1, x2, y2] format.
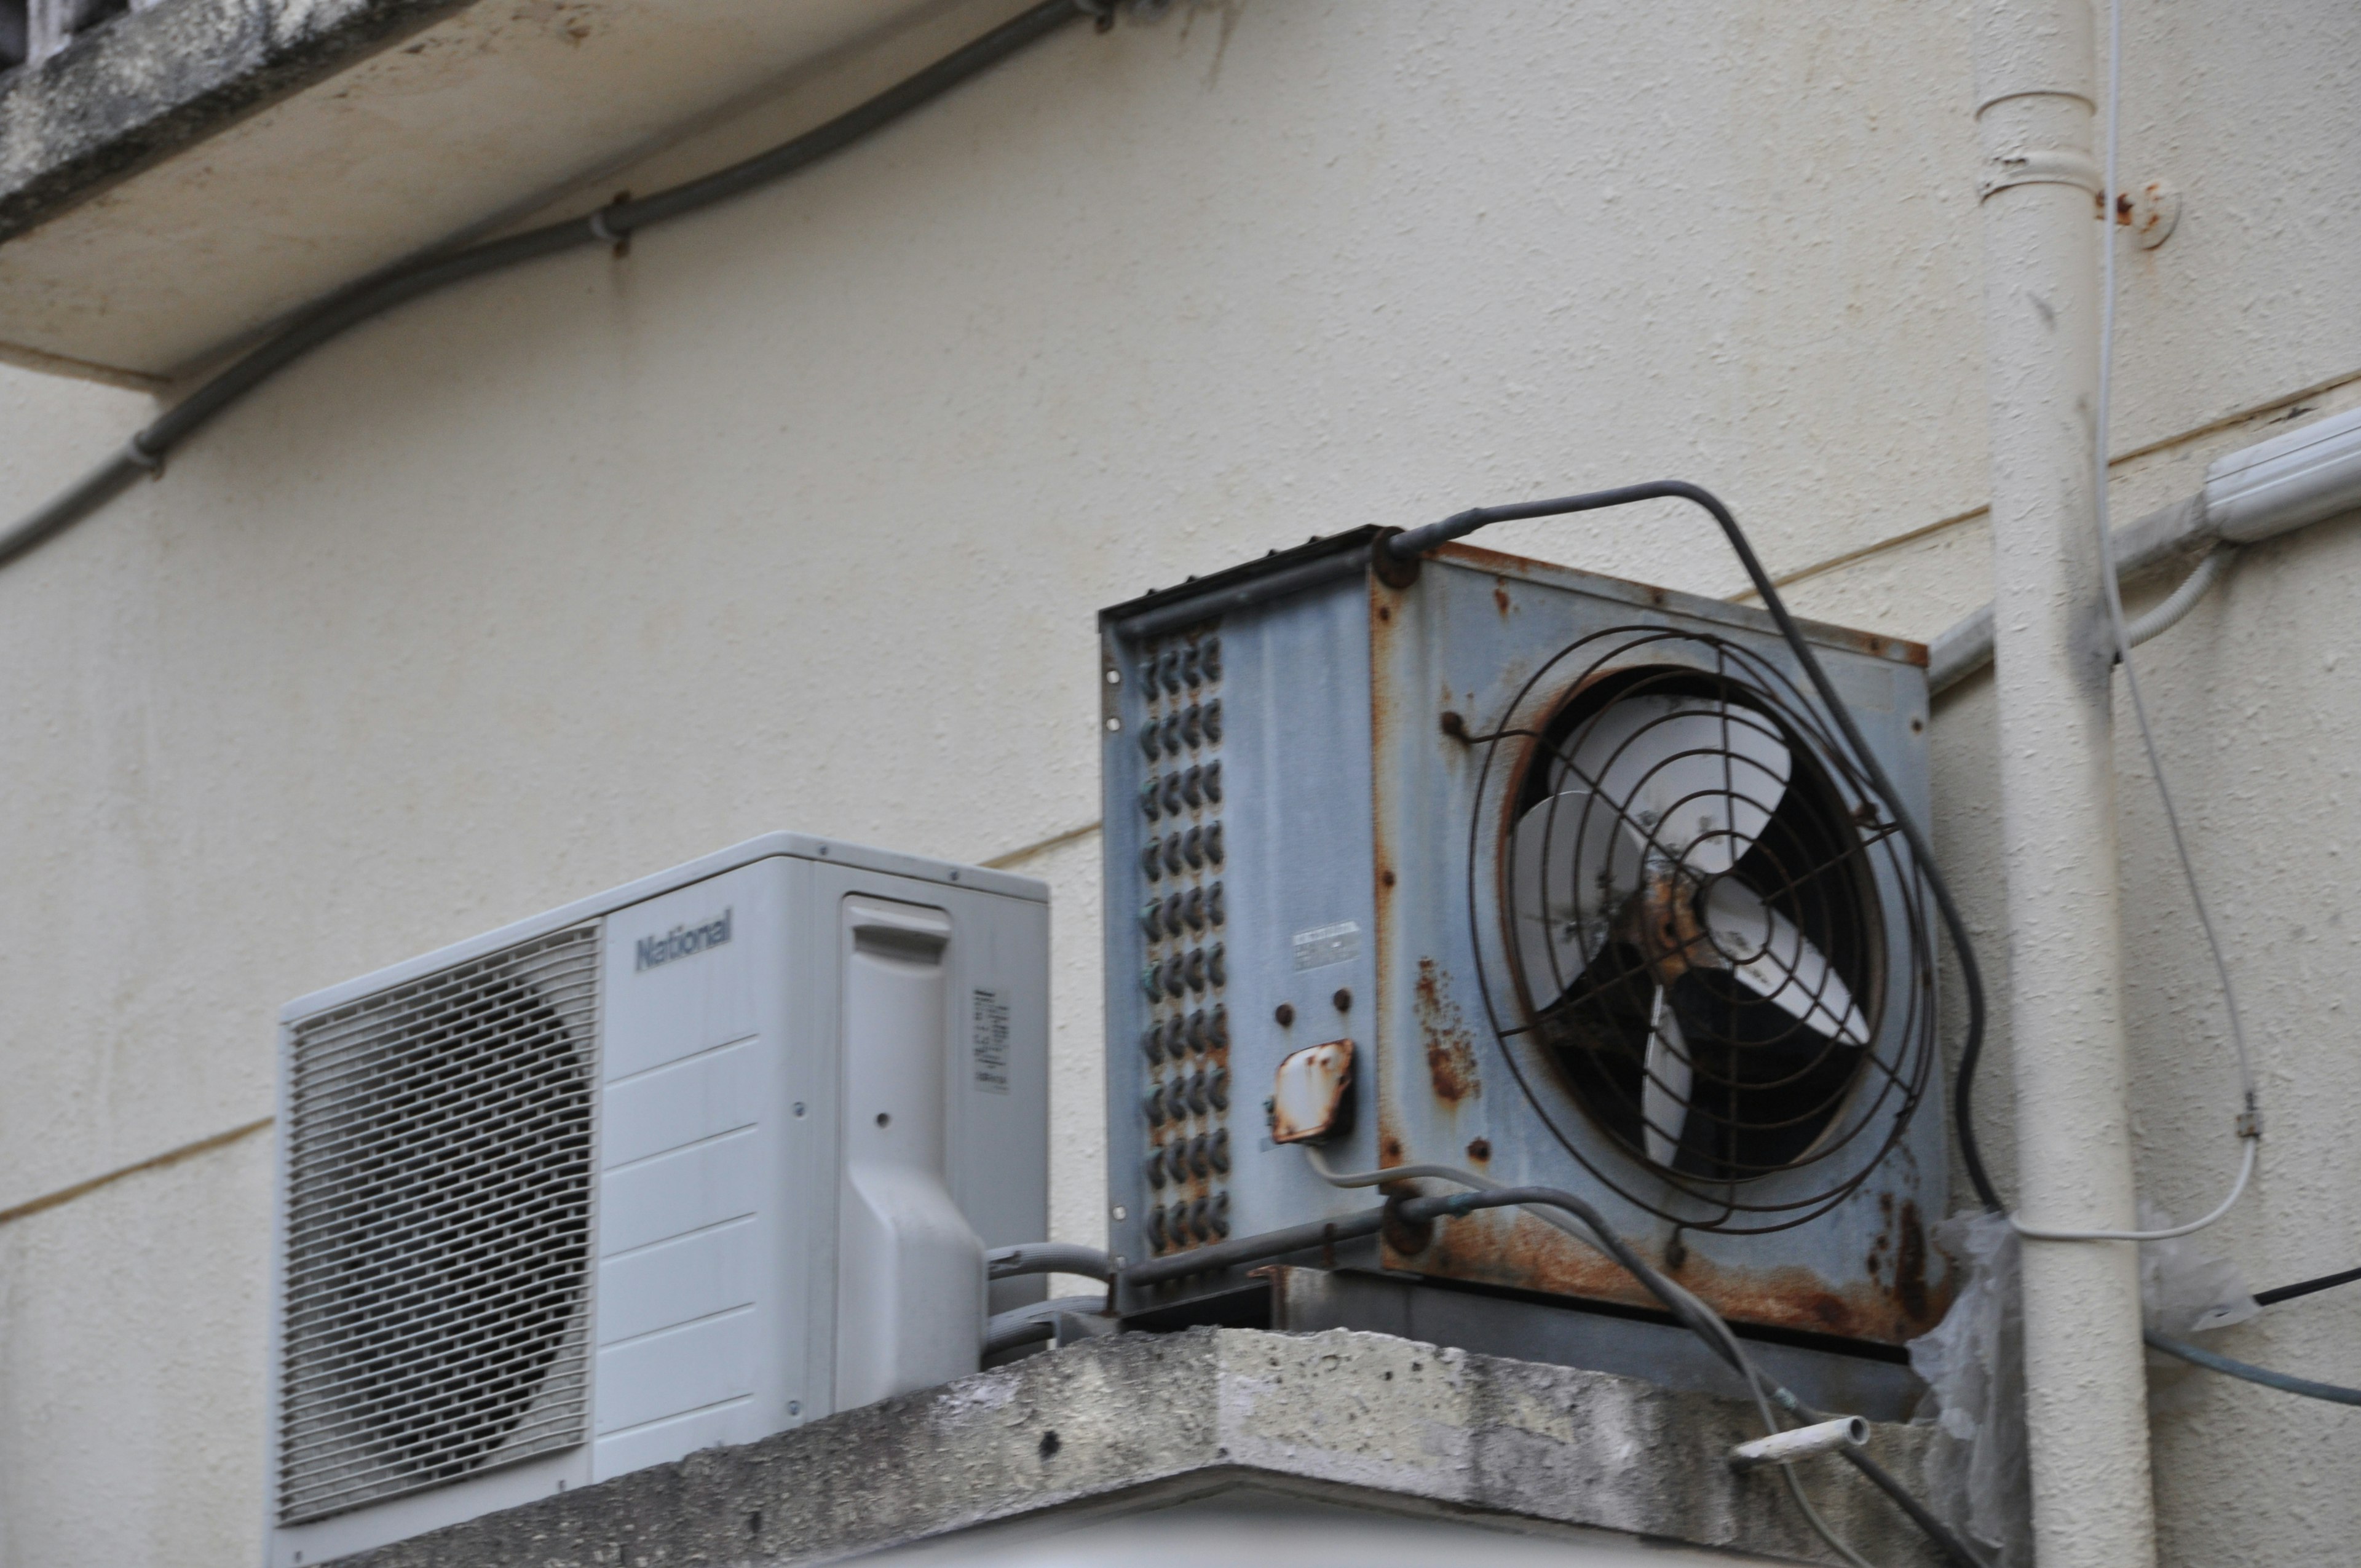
[0, 0, 2361, 1568]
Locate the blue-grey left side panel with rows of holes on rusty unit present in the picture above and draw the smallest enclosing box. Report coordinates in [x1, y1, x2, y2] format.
[1105, 571, 1377, 1294]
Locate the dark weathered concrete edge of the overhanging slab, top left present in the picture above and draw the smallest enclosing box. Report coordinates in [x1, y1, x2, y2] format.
[0, 0, 472, 241]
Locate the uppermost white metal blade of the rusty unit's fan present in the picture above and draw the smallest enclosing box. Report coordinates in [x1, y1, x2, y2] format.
[1568, 694, 1794, 876]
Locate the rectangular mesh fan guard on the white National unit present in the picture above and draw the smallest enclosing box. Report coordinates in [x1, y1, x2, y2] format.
[279, 924, 599, 1523]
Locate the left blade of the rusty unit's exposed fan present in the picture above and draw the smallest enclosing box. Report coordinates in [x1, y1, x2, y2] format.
[1509, 789, 1639, 1006]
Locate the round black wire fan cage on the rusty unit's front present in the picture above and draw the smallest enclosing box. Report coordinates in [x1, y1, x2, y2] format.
[1468, 626, 1936, 1233]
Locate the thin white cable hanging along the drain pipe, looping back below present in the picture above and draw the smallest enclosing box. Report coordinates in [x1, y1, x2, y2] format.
[2009, 0, 2262, 1242]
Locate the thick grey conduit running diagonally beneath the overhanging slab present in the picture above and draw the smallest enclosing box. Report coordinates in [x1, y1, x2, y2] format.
[0, 0, 1112, 567]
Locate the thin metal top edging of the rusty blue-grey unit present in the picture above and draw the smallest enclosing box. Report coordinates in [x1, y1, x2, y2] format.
[1098, 526, 1926, 668]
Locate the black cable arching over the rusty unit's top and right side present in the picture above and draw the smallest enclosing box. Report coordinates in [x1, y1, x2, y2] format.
[1381, 480, 2004, 1214]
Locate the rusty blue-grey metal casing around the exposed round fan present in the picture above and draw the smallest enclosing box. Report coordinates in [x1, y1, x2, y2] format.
[1100, 529, 1950, 1355]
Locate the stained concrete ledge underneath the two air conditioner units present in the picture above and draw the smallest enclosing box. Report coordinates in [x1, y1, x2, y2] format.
[345, 1329, 1936, 1568]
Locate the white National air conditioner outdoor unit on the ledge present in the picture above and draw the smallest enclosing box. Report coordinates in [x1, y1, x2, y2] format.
[267, 834, 1048, 1568]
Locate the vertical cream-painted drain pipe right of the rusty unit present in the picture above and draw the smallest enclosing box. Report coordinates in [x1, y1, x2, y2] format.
[1976, 0, 2156, 1568]
